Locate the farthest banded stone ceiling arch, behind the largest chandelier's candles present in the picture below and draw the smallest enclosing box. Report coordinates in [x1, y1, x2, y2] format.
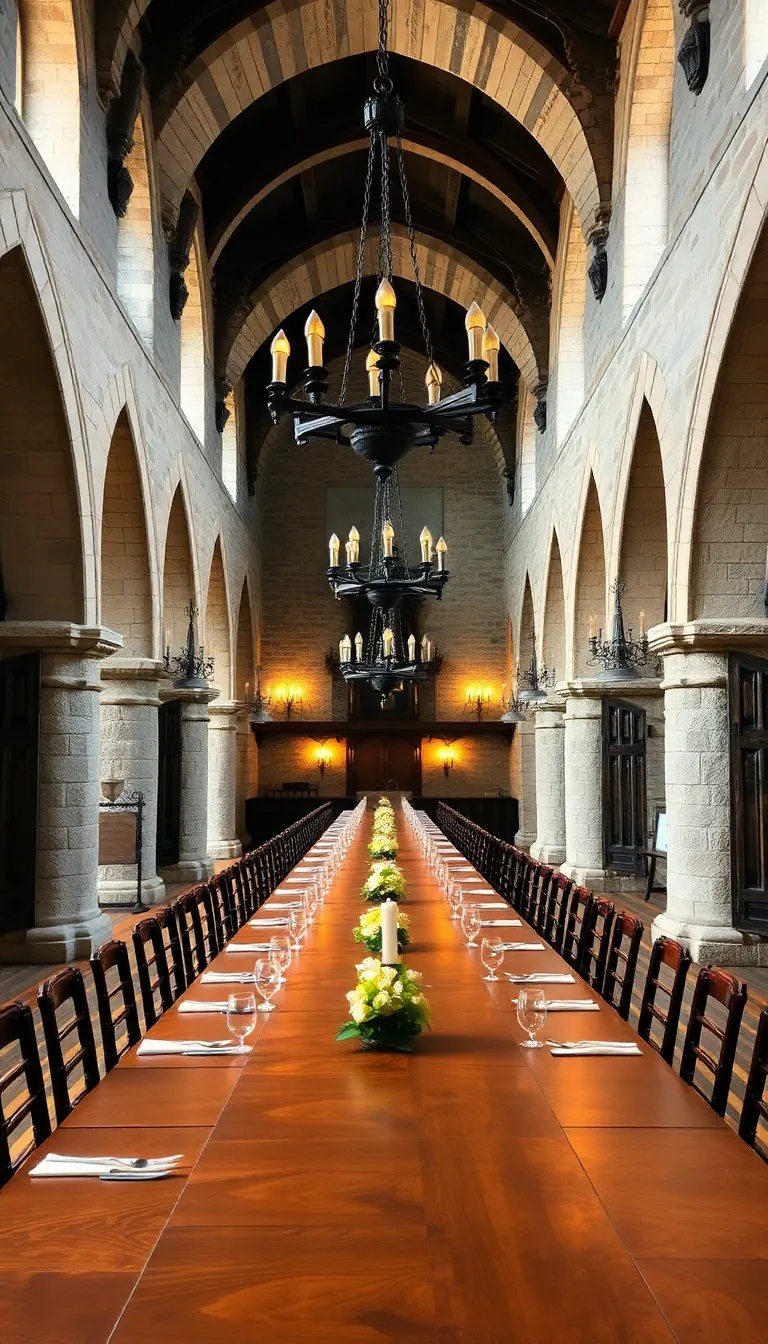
[222, 227, 546, 391]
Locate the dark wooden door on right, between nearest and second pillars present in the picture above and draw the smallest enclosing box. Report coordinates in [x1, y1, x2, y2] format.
[603, 700, 647, 872]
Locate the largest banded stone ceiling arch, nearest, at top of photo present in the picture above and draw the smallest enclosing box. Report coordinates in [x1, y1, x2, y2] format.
[157, 0, 611, 234]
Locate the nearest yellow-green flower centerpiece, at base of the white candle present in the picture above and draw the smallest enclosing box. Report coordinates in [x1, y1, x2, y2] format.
[336, 957, 429, 1051]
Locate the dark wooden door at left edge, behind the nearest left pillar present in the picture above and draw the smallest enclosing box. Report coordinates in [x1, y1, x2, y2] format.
[0, 653, 40, 933]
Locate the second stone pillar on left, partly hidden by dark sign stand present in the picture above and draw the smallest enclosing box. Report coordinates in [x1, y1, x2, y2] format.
[98, 659, 165, 906]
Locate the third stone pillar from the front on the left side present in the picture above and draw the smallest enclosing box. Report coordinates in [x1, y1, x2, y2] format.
[160, 688, 218, 882]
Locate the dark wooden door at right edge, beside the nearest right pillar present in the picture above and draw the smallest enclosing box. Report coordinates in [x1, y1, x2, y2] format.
[729, 653, 768, 933]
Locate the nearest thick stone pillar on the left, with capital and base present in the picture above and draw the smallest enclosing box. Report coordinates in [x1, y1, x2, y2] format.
[0, 621, 122, 964]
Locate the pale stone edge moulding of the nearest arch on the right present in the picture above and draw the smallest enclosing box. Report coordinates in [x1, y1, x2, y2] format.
[675, 149, 768, 622]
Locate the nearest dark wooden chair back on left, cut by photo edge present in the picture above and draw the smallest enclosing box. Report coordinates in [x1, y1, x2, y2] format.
[0, 1003, 51, 1187]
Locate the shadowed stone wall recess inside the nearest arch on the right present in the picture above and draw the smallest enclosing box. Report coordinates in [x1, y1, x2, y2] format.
[690, 217, 768, 620]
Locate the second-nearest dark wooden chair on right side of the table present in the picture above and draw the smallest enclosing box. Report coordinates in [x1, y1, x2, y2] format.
[681, 966, 746, 1116]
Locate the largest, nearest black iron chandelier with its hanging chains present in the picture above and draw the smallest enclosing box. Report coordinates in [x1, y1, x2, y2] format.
[266, 0, 502, 480]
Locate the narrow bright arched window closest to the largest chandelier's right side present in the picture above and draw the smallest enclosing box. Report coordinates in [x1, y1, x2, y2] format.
[555, 206, 586, 444]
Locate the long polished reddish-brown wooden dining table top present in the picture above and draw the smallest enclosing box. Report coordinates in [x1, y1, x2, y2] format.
[0, 816, 768, 1344]
